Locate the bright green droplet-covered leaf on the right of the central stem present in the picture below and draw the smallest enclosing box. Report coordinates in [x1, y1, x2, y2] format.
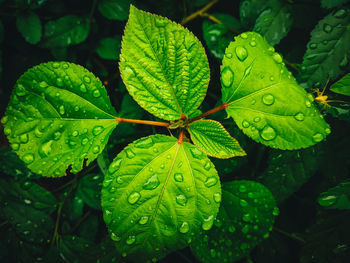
[221, 32, 330, 150]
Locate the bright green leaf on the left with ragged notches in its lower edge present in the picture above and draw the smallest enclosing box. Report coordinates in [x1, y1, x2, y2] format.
[1, 62, 117, 177]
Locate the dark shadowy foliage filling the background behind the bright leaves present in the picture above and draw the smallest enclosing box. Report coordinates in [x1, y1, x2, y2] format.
[0, 0, 350, 263]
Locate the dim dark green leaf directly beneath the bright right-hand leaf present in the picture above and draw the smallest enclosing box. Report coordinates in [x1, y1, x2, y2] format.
[259, 144, 325, 203]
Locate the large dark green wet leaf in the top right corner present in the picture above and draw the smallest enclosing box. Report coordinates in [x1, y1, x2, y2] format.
[299, 9, 350, 88]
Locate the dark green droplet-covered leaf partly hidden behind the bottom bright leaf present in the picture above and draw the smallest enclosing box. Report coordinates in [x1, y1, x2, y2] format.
[191, 180, 279, 263]
